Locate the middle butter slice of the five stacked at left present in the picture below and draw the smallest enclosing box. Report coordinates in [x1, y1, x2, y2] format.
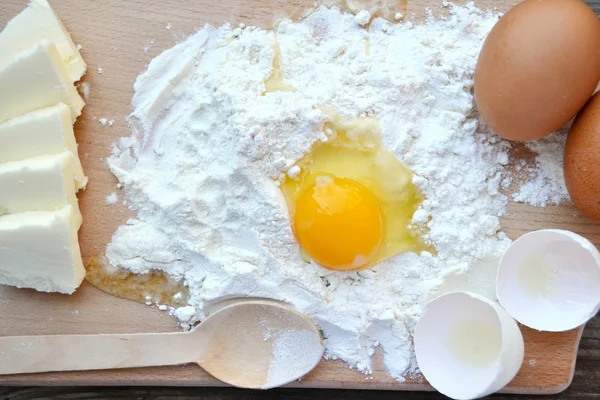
[0, 103, 87, 190]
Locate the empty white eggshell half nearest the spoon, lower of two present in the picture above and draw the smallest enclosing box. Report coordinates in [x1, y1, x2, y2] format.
[414, 292, 524, 400]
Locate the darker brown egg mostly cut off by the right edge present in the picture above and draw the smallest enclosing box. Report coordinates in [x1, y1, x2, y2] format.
[565, 94, 600, 219]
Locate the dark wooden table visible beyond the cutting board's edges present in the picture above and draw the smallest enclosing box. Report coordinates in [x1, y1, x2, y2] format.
[0, 0, 600, 400]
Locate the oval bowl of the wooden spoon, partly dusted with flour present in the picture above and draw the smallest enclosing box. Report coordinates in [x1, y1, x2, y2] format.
[190, 300, 324, 389]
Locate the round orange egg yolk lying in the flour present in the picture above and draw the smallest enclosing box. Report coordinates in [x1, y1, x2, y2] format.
[293, 175, 384, 270]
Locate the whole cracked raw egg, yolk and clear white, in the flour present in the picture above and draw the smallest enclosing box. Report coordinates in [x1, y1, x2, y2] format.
[280, 110, 432, 270]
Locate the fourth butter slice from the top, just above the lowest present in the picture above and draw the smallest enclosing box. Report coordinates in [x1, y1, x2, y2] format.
[0, 151, 82, 228]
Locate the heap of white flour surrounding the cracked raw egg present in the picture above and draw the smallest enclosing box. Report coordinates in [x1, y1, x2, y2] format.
[107, 5, 568, 380]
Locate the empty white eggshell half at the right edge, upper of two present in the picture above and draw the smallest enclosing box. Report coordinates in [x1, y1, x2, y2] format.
[496, 229, 600, 332]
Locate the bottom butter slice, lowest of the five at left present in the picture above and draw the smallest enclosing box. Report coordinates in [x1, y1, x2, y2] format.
[0, 206, 85, 294]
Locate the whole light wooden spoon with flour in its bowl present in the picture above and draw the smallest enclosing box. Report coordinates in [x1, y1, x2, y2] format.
[0, 300, 324, 389]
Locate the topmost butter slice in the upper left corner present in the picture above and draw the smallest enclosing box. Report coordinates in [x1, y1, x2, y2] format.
[0, 0, 87, 82]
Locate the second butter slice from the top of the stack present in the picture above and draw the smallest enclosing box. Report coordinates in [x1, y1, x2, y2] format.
[0, 40, 85, 123]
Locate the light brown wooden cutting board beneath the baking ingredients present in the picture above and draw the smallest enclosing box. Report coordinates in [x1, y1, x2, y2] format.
[0, 0, 600, 394]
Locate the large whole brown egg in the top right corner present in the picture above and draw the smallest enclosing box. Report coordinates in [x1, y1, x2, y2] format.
[475, 0, 600, 141]
